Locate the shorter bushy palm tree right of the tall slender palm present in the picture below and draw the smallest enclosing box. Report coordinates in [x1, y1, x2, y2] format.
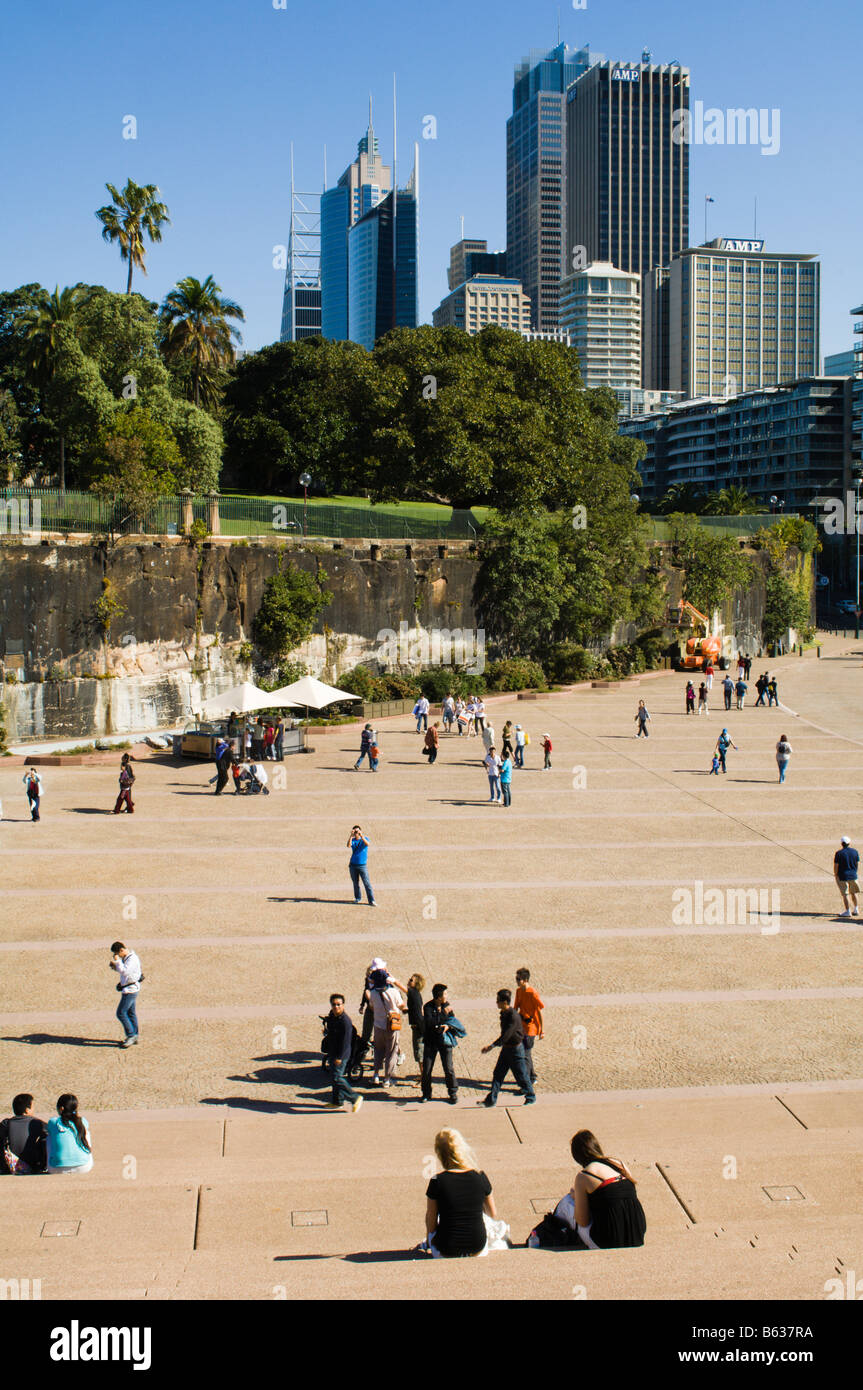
[160, 275, 246, 406]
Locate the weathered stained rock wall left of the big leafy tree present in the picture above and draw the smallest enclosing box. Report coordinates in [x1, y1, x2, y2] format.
[0, 539, 477, 741]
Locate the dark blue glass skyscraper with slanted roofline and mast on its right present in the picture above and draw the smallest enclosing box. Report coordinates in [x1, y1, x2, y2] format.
[347, 146, 420, 352]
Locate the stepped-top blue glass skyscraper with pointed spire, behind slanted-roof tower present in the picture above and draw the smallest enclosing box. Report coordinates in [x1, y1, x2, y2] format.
[321, 101, 392, 339]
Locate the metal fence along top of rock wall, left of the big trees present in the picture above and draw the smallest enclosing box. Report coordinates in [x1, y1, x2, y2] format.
[0, 488, 482, 541]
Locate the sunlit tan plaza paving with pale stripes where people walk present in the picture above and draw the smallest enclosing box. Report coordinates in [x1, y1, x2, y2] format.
[0, 638, 863, 1298]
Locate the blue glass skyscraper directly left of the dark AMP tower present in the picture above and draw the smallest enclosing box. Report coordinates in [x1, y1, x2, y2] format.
[506, 43, 594, 329]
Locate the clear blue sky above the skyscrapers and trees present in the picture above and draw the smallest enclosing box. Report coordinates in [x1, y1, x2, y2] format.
[0, 0, 863, 353]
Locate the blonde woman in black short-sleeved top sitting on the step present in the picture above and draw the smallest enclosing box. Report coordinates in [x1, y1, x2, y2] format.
[425, 1129, 498, 1259]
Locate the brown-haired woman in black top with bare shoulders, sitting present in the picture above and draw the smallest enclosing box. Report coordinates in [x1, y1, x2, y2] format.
[570, 1130, 648, 1250]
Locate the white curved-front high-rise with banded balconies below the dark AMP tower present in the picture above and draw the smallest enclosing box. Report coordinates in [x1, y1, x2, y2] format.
[559, 261, 641, 389]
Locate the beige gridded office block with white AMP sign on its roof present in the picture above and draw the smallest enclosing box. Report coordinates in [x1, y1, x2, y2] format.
[668, 236, 820, 398]
